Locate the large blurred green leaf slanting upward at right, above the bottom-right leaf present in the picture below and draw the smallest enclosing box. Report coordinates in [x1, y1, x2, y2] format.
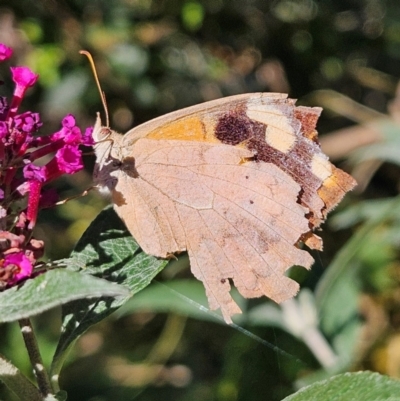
[315, 198, 400, 368]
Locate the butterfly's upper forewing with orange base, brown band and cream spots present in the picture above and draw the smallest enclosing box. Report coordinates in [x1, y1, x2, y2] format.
[124, 93, 356, 228]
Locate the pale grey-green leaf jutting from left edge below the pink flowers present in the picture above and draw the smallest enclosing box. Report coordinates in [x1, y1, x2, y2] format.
[0, 269, 129, 323]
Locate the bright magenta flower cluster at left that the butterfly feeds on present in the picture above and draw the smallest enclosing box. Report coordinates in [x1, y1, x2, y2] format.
[0, 44, 93, 290]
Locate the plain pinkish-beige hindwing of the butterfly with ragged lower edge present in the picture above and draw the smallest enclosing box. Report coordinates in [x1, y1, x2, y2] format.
[113, 139, 313, 321]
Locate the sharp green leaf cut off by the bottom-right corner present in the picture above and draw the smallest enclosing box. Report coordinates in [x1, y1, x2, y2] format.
[282, 372, 400, 401]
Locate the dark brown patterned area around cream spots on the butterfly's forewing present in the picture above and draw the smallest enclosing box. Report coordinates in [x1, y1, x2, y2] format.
[215, 98, 354, 229]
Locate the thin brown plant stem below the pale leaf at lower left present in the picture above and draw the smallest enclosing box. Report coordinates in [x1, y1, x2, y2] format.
[19, 319, 52, 396]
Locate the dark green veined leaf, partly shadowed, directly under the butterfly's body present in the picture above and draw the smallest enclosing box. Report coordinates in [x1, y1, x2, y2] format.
[52, 208, 167, 380]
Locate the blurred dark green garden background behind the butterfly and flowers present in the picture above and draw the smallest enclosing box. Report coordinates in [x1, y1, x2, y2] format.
[0, 0, 400, 401]
